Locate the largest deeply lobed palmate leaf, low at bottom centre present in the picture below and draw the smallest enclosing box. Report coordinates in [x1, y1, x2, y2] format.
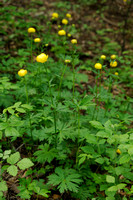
[48, 167, 82, 193]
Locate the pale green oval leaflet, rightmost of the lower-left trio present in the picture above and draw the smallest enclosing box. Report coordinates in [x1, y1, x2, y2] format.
[17, 158, 34, 170]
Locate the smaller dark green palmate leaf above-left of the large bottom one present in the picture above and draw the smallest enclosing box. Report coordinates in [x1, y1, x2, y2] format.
[34, 144, 57, 164]
